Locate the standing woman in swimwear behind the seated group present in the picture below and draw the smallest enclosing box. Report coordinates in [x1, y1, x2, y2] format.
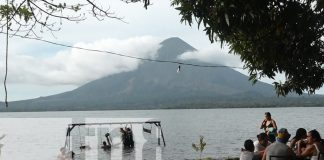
[260, 112, 277, 143]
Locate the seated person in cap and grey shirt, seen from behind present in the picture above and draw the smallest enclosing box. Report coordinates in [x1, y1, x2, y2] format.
[262, 128, 296, 160]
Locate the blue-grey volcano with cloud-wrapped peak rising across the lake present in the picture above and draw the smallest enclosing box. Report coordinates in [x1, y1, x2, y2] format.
[1, 38, 304, 110]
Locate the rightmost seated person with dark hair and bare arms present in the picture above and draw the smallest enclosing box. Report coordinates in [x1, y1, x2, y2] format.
[297, 130, 324, 160]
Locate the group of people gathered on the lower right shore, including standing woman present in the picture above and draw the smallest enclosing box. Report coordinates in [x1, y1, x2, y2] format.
[240, 112, 324, 160]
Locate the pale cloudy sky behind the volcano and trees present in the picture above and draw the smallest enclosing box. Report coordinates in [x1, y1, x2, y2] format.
[0, 0, 322, 101]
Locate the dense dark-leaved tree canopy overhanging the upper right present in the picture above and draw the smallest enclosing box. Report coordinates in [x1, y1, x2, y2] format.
[172, 0, 324, 96]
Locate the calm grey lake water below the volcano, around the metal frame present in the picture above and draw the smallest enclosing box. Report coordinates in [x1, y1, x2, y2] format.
[0, 107, 324, 160]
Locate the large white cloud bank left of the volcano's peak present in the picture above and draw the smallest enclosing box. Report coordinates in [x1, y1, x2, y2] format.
[0, 36, 160, 85]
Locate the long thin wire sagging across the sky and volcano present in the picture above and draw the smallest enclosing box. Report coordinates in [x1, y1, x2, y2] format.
[0, 32, 243, 69]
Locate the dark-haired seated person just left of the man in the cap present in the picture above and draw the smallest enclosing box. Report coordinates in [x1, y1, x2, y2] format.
[254, 133, 271, 160]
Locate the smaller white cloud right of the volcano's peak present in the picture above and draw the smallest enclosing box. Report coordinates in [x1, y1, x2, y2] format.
[178, 45, 243, 67]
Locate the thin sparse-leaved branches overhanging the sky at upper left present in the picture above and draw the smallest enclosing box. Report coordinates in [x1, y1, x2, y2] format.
[0, 0, 150, 37]
